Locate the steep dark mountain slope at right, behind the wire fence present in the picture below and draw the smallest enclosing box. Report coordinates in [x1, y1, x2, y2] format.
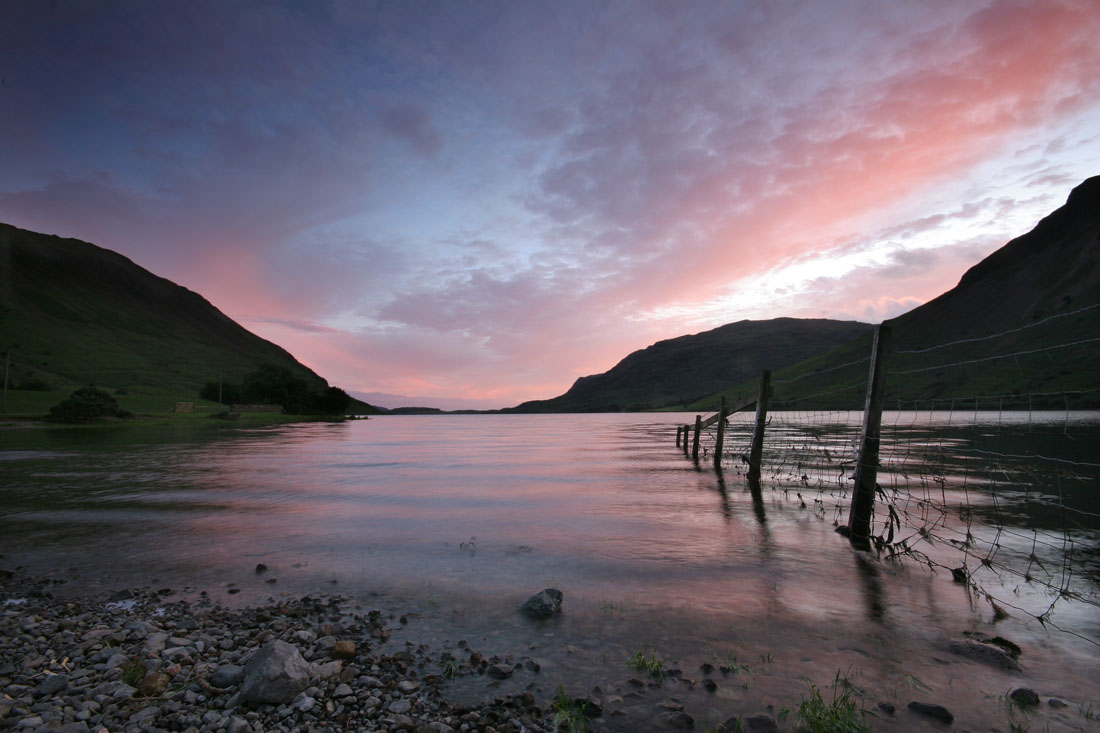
[691, 176, 1100, 409]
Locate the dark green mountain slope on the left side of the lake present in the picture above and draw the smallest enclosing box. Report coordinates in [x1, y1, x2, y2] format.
[0, 223, 382, 406]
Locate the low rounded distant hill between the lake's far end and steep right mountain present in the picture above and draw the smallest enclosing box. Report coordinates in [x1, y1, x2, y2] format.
[508, 318, 871, 413]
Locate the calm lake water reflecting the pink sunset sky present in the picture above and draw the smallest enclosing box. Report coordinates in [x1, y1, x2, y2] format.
[0, 414, 1100, 730]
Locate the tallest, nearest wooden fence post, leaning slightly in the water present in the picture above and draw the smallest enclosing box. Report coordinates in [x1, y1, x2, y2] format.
[848, 324, 891, 544]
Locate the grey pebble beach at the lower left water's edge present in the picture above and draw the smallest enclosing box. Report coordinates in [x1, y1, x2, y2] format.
[0, 570, 553, 733]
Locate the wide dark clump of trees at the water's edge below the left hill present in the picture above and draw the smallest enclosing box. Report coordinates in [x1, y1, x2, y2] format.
[199, 363, 351, 415]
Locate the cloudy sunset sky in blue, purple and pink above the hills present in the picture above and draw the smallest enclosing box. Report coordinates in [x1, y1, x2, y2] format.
[0, 0, 1100, 408]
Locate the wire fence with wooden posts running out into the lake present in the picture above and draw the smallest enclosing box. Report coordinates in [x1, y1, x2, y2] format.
[677, 306, 1100, 645]
